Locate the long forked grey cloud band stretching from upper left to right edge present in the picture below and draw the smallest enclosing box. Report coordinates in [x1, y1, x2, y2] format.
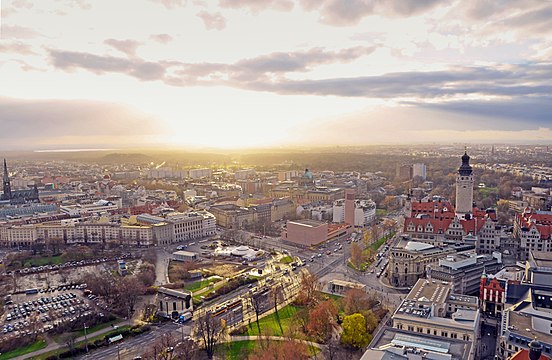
[50, 47, 552, 107]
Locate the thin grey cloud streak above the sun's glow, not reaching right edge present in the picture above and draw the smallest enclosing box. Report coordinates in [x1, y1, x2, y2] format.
[49, 47, 375, 83]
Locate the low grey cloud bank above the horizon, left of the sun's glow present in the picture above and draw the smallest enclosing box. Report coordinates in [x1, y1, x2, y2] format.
[0, 97, 158, 148]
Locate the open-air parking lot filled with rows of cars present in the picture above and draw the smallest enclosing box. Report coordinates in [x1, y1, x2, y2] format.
[0, 284, 99, 337]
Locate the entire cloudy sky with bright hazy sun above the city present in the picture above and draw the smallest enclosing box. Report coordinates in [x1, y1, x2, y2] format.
[0, 0, 552, 150]
